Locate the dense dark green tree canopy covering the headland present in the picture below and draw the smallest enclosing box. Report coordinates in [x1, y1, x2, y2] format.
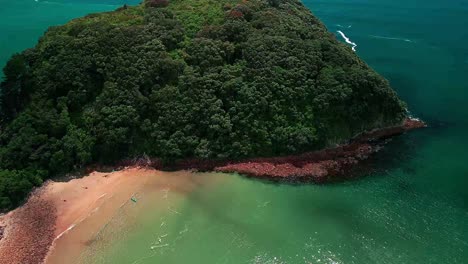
[0, 0, 406, 208]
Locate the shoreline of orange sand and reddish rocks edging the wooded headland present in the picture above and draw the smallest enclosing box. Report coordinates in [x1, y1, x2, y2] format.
[0, 119, 425, 264]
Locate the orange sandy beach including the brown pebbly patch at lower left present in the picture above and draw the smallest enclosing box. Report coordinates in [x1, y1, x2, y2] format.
[0, 168, 158, 264]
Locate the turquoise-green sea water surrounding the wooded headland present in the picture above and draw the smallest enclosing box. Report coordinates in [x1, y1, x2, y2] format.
[0, 0, 468, 264]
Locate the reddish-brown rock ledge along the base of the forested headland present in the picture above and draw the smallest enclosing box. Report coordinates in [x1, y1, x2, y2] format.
[116, 118, 426, 182]
